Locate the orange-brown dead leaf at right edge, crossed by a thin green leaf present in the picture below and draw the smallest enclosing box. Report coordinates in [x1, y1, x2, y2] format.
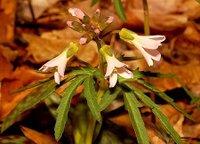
[152, 61, 200, 91]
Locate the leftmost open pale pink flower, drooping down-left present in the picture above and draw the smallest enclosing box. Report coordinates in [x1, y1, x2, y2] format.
[39, 43, 78, 84]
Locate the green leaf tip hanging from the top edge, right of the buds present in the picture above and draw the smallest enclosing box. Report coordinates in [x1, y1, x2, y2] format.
[114, 0, 127, 22]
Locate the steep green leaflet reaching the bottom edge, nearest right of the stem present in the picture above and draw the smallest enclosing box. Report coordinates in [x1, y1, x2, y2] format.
[124, 92, 149, 144]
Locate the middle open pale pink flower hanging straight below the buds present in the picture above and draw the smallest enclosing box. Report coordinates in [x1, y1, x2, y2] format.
[101, 45, 133, 88]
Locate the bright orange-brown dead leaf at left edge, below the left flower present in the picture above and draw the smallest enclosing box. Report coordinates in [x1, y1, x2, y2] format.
[0, 66, 47, 119]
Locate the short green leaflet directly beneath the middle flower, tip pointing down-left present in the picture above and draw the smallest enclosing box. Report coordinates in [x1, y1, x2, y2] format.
[99, 87, 121, 111]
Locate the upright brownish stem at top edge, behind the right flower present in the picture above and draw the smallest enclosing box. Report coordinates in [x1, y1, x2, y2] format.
[143, 0, 150, 35]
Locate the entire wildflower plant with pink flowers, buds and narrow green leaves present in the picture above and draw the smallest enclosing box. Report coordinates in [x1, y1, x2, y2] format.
[1, 8, 193, 144]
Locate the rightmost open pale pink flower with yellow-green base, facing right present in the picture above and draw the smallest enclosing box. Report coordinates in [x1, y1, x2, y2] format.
[119, 28, 165, 66]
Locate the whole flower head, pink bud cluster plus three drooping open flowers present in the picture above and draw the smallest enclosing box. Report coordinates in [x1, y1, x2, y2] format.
[39, 8, 165, 88]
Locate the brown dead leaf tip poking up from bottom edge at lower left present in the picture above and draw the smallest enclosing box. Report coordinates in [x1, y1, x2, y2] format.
[21, 126, 58, 144]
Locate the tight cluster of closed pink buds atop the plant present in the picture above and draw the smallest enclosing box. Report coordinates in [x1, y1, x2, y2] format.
[67, 8, 114, 45]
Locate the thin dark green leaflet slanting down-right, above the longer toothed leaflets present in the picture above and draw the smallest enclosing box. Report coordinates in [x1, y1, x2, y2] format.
[137, 80, 194, 121]
